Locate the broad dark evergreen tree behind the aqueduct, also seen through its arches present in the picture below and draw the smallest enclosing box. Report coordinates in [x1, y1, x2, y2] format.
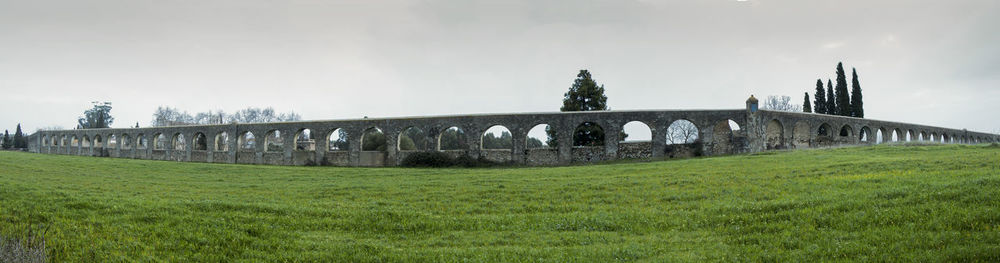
[545, 69, 608, 147]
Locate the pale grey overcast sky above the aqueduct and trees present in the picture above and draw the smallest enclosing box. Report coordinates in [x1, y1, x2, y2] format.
[0, 0, 1000, 135]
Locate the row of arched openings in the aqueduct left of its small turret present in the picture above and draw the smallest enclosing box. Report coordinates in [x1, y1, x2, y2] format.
[35, 119, 740, 152]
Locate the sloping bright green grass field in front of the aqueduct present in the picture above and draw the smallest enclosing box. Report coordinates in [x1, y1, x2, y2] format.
[0, 145, 1000, 262]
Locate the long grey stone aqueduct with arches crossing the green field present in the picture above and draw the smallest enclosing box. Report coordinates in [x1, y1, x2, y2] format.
[29, 100, 1000, 166]
